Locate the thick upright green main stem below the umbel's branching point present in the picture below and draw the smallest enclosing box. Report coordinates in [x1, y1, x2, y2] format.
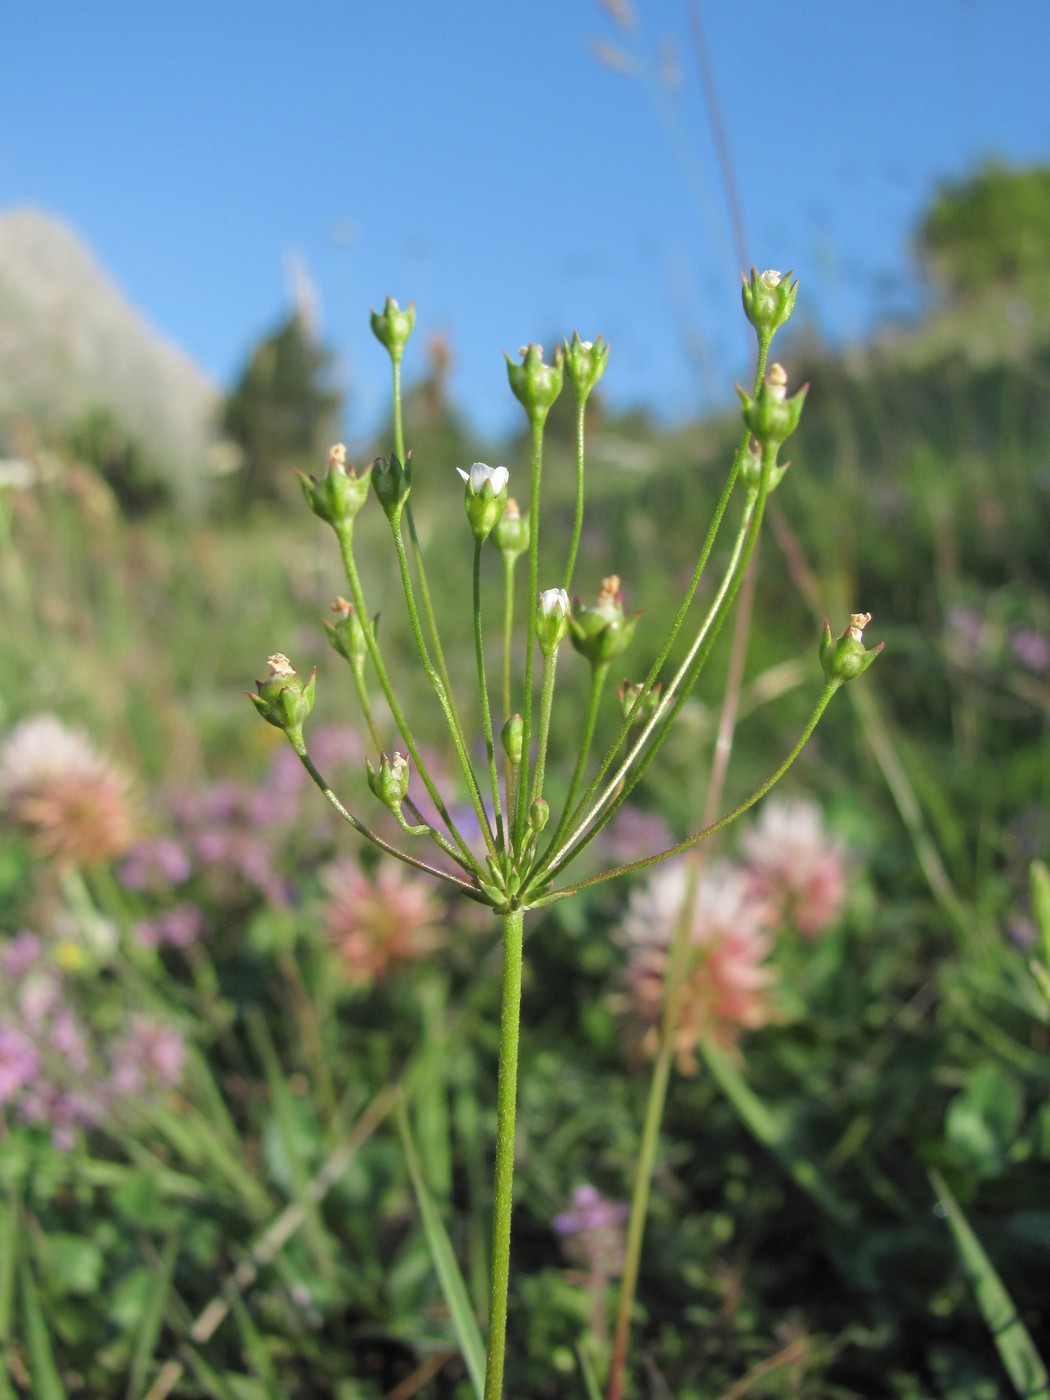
[484, 909, 525, 1400]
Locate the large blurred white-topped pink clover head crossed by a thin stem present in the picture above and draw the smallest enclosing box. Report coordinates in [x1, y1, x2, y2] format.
[622, 860, 773, 1071]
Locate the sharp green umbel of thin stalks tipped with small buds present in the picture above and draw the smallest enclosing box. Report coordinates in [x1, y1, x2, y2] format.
[251, 270, 881, 914]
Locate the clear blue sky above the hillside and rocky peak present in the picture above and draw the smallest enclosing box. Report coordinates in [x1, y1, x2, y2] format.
[0, 0, 1050, 441]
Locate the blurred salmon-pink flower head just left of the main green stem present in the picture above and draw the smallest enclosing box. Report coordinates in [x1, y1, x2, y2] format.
[321, 858, 444, 984]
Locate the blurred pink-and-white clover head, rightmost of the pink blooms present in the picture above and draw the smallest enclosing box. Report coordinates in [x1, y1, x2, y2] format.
[741, 797, 847, 938]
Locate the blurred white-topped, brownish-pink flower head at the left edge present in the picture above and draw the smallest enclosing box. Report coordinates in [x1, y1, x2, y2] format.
[0, 714, 133, 865]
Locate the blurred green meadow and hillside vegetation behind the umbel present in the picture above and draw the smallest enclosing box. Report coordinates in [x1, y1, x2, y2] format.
[0, 168, 1050, 1400]
